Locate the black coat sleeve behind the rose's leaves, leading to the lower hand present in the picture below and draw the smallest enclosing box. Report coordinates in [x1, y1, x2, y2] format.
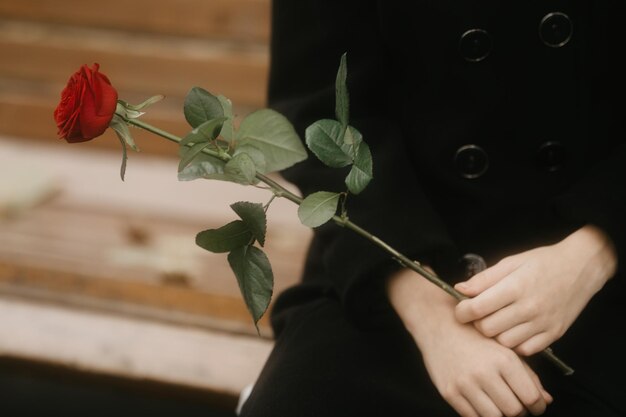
[269, 0, 458, 322]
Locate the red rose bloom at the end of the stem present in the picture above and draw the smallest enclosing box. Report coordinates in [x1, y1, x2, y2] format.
[54, 64, 117, 143]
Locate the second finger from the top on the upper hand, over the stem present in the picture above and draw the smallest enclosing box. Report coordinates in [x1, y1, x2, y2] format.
[454, 280, 516, 323]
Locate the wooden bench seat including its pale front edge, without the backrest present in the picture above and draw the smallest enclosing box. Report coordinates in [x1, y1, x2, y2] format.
[0, 133, 310, 403]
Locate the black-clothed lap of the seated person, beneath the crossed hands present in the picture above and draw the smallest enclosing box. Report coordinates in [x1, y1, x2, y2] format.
[241, 286, 620, 417]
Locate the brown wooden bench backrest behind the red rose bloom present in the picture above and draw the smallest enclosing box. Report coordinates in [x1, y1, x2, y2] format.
[0, 0, 270, 152]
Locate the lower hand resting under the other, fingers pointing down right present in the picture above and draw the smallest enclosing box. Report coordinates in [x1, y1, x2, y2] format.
[387, 270, 552, 417]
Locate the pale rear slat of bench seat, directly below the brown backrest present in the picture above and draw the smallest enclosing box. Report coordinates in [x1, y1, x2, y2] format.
[0, 138, 309, 228]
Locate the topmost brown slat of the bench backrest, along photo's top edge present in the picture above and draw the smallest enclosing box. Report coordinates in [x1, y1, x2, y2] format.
[0, 0, 270, 42]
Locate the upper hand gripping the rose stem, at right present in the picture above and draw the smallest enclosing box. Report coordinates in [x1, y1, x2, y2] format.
[455, 226, 617, 356]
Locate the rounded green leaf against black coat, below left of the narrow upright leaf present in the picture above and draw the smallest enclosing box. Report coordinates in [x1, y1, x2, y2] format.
[305, 119, 352, 168]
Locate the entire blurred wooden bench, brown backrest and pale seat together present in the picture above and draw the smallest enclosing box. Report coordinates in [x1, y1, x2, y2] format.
[0, 0, 310, 410]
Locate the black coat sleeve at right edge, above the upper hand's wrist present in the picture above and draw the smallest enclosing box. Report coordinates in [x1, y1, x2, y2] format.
[555, 6, 626, 276]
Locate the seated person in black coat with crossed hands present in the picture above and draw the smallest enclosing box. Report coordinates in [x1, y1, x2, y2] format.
[236, 0, 626, 417]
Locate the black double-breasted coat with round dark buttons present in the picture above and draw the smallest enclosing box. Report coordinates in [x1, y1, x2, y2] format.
[238, 0, 626, 415]
